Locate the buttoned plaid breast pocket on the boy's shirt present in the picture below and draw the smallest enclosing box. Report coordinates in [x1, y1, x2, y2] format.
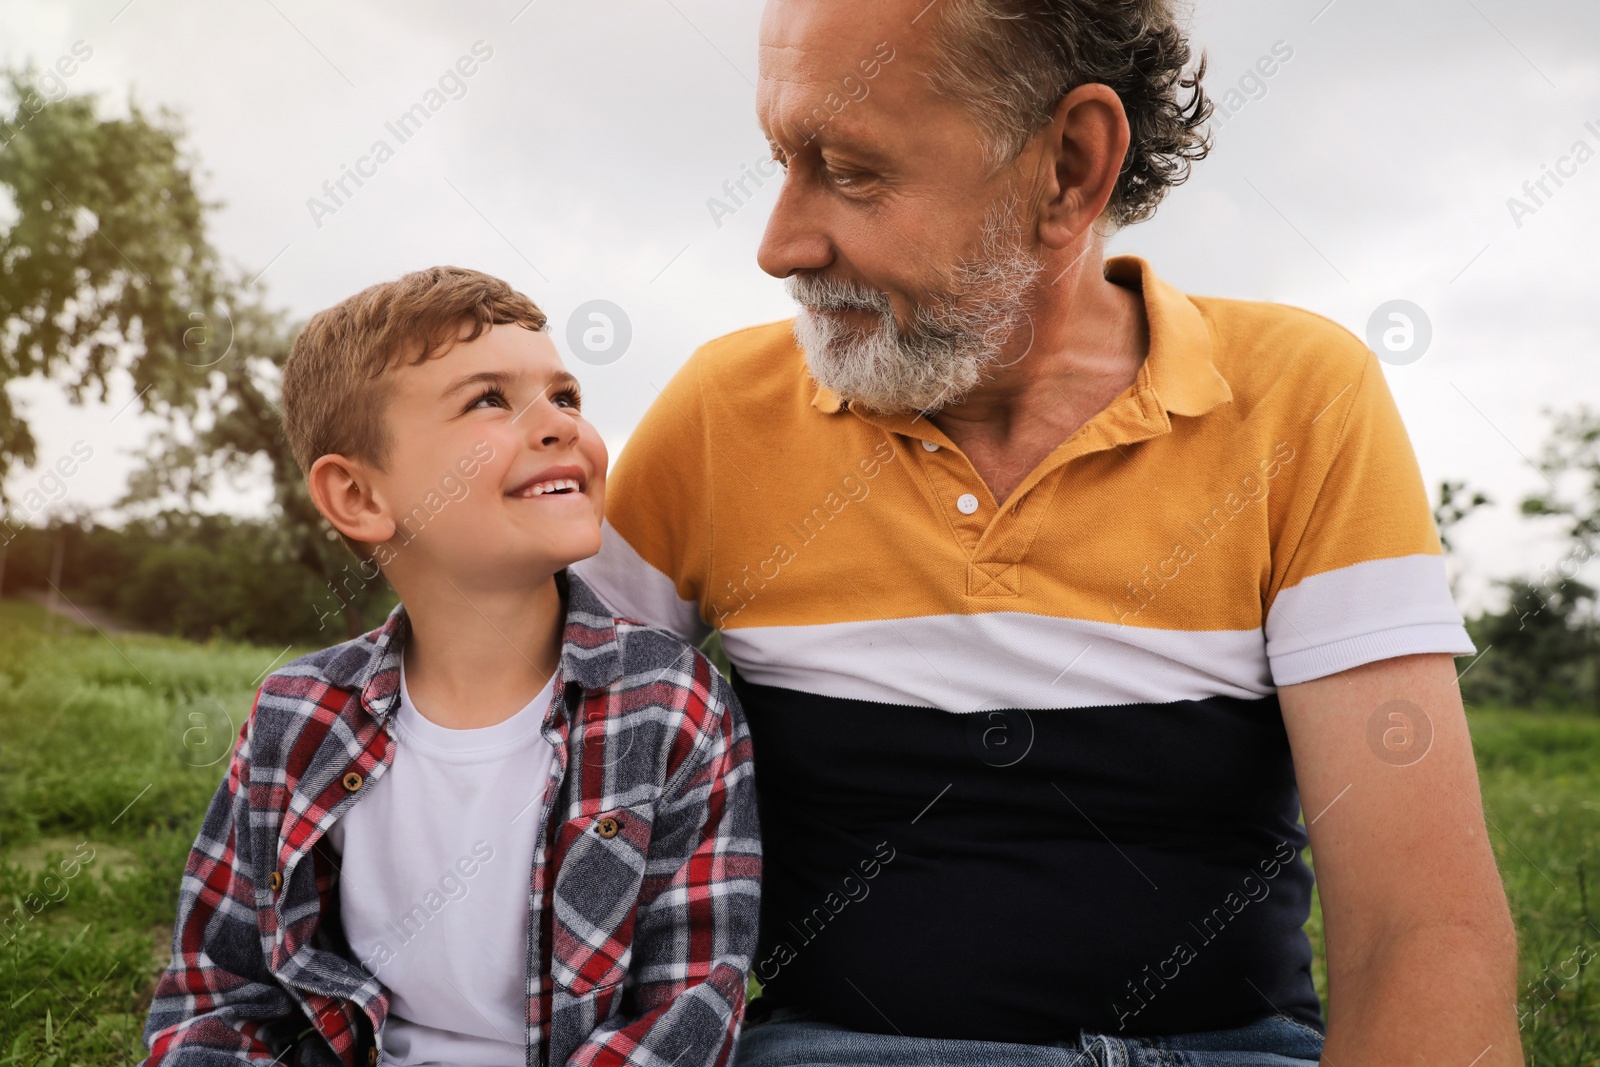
[550, 805, 653, 997]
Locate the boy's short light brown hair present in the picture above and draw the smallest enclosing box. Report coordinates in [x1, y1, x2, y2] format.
[282, 267, 547, 560]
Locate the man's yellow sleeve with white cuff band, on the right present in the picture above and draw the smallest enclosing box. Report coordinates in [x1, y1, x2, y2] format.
[1266, 352, 1475, 686]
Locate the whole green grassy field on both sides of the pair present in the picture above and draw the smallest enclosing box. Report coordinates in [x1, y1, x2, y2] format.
[0, 600, 1600, 1067]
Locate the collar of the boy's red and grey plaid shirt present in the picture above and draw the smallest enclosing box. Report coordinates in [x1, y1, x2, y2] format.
[347, 569, 622, 721]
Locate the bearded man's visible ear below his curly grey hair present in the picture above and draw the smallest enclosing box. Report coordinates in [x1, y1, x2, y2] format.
[1038, 83, 1131, 248]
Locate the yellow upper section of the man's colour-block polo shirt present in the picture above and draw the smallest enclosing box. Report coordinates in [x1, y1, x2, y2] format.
[608, 256, 1440, 630]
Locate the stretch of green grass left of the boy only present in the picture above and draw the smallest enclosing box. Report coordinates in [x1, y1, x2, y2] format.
[0, 600, 318, 1067]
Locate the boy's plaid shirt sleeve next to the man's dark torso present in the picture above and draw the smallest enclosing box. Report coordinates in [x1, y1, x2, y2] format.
[568, 653, 762, 1067]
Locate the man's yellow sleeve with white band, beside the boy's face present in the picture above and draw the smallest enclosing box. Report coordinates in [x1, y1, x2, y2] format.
[573, 355, 714, 645]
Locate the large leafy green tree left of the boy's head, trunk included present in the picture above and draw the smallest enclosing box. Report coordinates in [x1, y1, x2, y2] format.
[0, 72, 387, 637]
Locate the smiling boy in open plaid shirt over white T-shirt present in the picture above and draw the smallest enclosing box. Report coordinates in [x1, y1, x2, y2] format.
[146, 267, 762, 1067]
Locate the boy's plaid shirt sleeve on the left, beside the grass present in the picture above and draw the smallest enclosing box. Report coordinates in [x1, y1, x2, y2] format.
[144, 693, 309, 1067]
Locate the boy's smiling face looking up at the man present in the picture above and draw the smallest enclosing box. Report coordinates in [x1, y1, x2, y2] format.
[350, 323, 606, 584]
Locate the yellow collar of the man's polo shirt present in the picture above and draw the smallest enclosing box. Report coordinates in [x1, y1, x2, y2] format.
[811, 256, 1234, 416]
